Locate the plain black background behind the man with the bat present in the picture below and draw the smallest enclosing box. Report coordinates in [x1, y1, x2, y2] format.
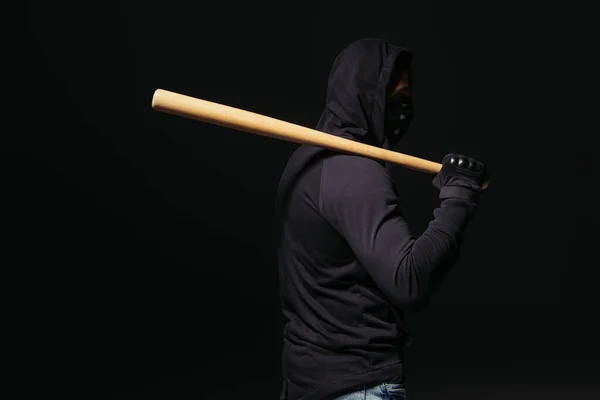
[5, 0, 600, 400]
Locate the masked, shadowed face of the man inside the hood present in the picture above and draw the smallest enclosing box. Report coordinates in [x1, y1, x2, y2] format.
[384, 66, 414, 147]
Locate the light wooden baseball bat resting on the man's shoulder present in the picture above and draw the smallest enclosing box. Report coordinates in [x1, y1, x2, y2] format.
[152, 89, 487, 186]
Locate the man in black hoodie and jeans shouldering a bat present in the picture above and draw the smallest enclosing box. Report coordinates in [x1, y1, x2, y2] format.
[277, 39, 486, 400]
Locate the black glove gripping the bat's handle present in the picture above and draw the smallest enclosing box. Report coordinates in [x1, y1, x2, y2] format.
[433, 153, 490, 201]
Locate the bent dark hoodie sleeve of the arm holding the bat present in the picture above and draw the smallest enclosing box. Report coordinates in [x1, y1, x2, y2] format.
[319, 155, 476, 307]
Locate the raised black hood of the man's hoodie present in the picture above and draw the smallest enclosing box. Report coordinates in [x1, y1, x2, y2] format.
[277, 38, 412, 212]
